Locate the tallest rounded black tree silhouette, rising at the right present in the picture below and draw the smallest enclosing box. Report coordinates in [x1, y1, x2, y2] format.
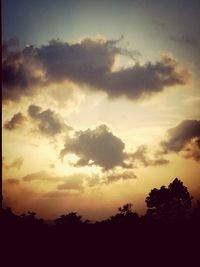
[145, 178, 192, 225]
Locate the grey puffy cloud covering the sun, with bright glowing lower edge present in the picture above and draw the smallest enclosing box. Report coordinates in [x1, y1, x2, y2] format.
[60, 125, 130, 170]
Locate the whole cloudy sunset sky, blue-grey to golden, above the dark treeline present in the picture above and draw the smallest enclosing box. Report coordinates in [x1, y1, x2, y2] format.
[2, 0, 200, 220]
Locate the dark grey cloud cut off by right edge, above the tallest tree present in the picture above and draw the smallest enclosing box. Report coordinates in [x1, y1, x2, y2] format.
[160, 120, 200, 161]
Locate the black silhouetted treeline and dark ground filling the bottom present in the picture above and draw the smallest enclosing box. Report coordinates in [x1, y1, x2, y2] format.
[0, 178, 200, 267]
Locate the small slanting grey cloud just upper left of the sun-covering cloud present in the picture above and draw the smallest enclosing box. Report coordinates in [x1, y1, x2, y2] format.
[28, 105, 72, 136]
